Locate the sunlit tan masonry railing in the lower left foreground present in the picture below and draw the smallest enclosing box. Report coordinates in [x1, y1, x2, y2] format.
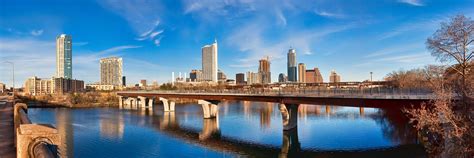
[13, 103, 60, 158]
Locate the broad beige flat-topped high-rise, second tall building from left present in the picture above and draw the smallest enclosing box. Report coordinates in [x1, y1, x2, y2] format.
[100, 57, 124, 86]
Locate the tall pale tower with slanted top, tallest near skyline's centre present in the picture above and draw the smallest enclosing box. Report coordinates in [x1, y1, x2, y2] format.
[202, 40, 218, 82]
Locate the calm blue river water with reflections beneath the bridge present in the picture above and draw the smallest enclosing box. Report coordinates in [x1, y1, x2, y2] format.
[28, 102, 424, 157]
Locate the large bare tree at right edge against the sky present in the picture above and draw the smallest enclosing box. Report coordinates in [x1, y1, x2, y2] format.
[426, 15, 474, 101]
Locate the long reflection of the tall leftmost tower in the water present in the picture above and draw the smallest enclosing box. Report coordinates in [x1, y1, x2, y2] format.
[56, 108, 74, 157]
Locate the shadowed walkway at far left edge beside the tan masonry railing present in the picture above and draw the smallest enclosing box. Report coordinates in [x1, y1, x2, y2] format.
[0, 100, 16, 158]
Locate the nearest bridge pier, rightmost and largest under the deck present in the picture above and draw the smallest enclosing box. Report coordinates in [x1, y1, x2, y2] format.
[278, 104, 299, 131]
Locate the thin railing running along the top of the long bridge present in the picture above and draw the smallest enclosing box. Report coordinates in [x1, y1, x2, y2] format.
[128, 87, 434, 99]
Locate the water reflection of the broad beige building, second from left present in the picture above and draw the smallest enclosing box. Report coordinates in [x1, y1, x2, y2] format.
[100, 111, 125, 139]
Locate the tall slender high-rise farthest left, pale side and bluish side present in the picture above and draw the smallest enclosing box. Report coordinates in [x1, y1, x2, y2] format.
[56, 34, 72, 79]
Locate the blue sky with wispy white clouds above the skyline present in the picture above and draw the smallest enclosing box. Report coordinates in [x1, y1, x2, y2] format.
[0, 0, 474, 85]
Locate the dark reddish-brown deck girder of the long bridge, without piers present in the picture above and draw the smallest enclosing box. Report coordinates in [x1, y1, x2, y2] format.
[117, 91, 430, 107]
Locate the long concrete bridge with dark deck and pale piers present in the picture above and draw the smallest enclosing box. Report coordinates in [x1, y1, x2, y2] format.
[117, 91, 431, 130]
